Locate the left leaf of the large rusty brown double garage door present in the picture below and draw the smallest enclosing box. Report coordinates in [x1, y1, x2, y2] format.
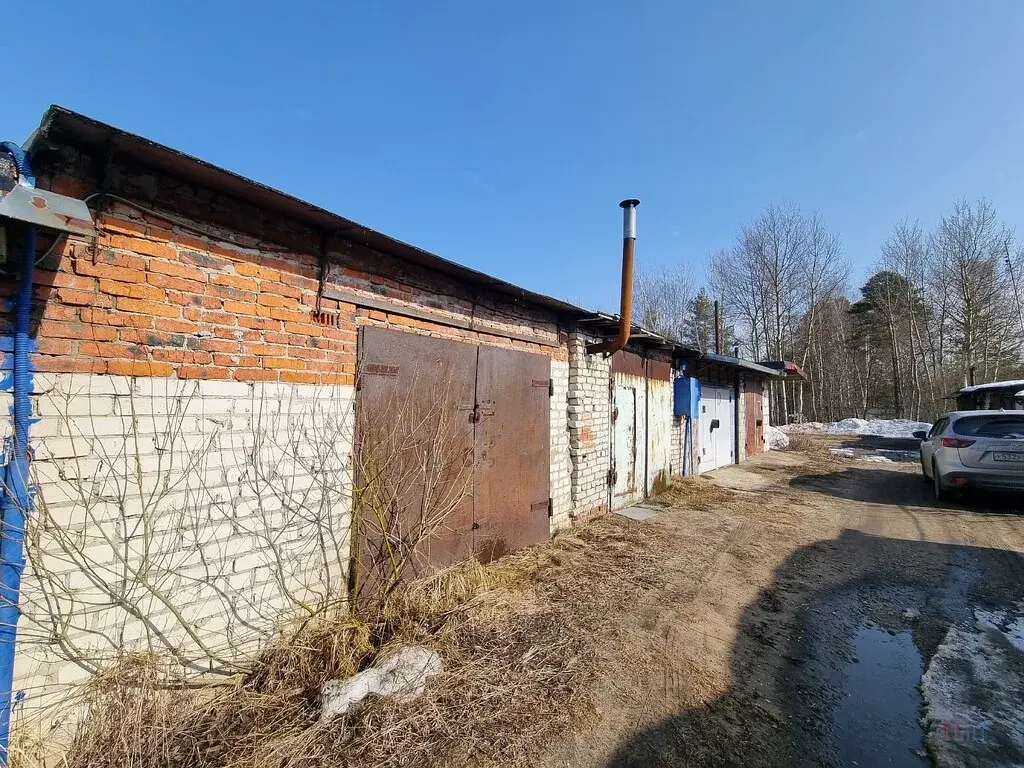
[353, 328, 476, 590]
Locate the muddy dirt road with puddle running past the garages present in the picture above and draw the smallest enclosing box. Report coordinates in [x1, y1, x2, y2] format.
[540, 439, 1024, 768]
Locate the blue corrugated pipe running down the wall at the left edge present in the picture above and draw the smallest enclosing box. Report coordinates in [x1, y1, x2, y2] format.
[0, 141, 36, 766]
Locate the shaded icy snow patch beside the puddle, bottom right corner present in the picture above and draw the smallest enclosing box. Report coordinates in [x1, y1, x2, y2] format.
[921, 603, 1024, 766]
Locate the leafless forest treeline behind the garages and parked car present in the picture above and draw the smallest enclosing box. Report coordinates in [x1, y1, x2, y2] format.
[635, 199, 1024, 424]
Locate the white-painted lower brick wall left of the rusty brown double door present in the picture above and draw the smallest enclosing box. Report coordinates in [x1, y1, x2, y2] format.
[11, 374, 356, 711]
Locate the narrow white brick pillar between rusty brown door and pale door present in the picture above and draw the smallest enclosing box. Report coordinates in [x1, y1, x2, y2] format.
[568, 334, 611, 515]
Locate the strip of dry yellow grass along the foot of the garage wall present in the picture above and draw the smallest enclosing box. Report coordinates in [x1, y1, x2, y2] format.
[22, 520, 656, 768]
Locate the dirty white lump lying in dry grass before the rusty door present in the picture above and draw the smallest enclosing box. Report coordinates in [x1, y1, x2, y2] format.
[321, 645, 443, 720]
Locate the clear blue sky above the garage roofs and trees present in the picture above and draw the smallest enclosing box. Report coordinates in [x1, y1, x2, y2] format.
[8, 0, 1024, 309]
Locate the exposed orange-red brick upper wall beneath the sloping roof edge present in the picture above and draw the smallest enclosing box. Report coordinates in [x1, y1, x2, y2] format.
[18, 147, 567, 384]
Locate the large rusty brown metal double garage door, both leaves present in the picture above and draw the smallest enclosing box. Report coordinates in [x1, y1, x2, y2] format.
[354, 327, 551, 581]
